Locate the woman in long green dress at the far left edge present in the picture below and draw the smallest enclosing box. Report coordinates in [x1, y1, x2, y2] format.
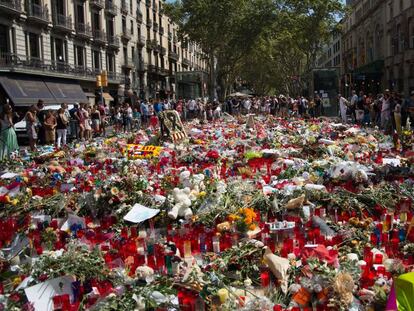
[0, 104, 19, 161]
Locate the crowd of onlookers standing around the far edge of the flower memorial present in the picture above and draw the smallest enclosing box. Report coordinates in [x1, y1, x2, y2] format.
[0, 90, 414, 160]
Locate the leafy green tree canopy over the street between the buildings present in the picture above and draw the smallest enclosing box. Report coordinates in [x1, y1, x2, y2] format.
[164, 0, 343, 98]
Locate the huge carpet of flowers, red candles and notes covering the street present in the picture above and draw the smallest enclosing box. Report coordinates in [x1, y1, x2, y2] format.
[0, 116, 414, 311]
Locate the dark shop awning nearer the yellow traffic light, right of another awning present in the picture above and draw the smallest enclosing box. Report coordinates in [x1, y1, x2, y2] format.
[45, 81, 88, 104]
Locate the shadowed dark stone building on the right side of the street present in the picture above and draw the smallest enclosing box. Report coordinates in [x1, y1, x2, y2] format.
[342, 0, 414, 95]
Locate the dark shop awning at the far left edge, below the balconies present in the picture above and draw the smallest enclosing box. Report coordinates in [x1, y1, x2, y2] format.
[0, 77, 56, 106]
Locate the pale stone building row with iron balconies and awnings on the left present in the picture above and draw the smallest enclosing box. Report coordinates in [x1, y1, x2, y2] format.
[0, 0, 207, 105]
